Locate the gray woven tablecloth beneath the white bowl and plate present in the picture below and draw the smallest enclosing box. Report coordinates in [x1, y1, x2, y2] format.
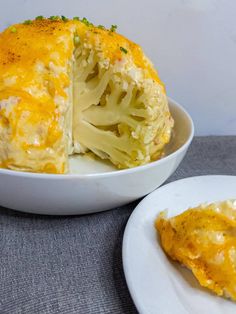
[0, 137, 236, 314]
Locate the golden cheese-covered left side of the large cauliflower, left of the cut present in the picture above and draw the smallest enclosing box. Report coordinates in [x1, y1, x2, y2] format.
[0, 19, 75, 173]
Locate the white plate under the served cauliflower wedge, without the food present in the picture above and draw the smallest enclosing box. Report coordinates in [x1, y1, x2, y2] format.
[123, 176, 236, 314]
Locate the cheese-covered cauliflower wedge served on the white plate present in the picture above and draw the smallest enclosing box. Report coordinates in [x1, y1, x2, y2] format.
[156, 201, 236, 300]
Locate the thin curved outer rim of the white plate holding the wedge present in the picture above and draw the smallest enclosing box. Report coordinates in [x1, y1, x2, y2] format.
[122, 174, 236, 314]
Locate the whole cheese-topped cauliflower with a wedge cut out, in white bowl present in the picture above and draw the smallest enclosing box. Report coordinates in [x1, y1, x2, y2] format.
[0, 17, 173, 173]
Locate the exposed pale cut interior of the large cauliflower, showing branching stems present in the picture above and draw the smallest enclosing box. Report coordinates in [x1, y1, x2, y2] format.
[73, 32, 172, 168]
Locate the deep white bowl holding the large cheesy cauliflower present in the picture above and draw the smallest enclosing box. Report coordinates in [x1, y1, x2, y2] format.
[0, 99, 194, 215]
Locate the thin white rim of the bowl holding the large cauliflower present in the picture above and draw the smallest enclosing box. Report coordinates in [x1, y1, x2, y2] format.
[0, 97, 194, 180]
